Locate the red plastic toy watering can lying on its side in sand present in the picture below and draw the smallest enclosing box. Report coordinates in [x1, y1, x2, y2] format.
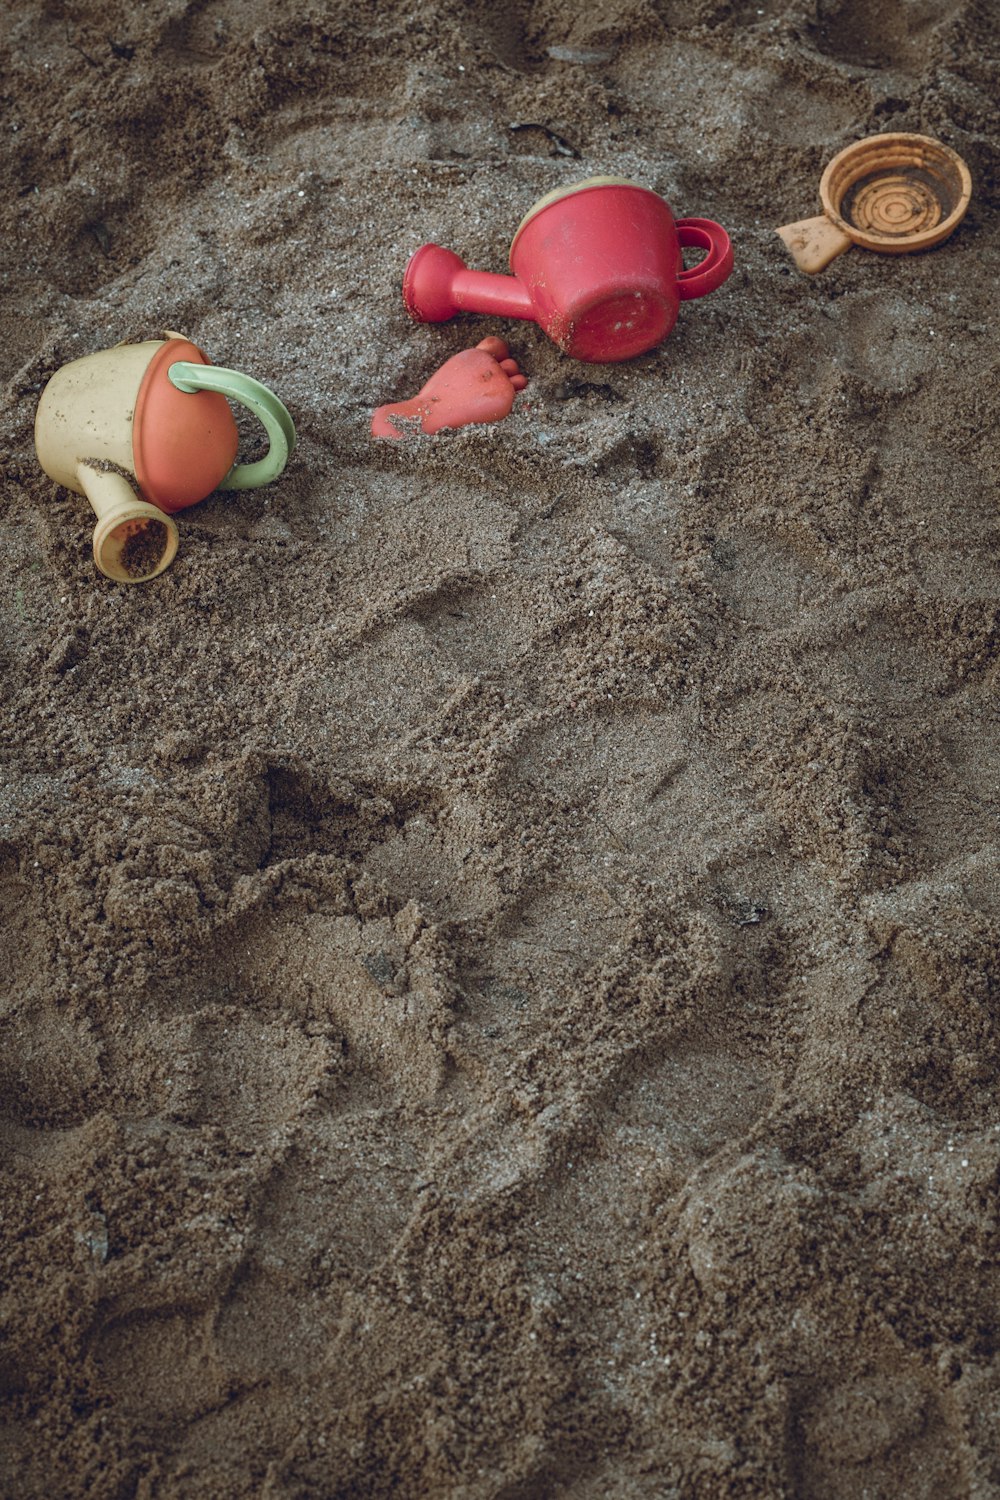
[403, 177, 733, 363]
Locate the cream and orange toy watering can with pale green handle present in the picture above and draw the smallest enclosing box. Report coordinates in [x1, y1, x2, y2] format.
[34, 333, 295, 584]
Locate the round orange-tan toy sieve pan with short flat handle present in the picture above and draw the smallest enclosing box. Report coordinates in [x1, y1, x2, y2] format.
[777, 135, 972, 273]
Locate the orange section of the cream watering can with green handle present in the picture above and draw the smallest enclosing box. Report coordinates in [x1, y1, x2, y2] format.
[132, 338, 238, 515]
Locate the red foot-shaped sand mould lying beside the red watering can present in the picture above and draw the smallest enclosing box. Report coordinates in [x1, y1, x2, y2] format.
[372, 338, 528, 440]
